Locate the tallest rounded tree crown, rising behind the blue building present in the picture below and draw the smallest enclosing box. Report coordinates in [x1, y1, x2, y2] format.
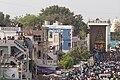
[39, 5, 74, 25]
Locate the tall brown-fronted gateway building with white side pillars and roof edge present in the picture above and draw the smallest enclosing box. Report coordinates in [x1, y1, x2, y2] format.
[88, 18, 111, 52]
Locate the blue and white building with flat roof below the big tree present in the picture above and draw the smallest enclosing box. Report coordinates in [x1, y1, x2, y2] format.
[42, 21, 72, 52]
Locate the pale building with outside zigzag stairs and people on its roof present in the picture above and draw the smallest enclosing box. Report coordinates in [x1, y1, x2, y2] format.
[0, 27, 32, 80]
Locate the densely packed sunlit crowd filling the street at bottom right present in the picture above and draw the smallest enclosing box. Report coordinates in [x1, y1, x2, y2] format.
[64, 61, 120, 80]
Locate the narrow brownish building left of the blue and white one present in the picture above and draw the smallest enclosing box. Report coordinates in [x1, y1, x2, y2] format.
[32, 27, 48, 64]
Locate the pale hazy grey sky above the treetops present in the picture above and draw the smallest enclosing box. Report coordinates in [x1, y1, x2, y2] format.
[0, 0, 120, 21]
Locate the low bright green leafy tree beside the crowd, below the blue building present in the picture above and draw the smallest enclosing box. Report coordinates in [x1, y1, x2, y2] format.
[59, 46, 90, 69]
